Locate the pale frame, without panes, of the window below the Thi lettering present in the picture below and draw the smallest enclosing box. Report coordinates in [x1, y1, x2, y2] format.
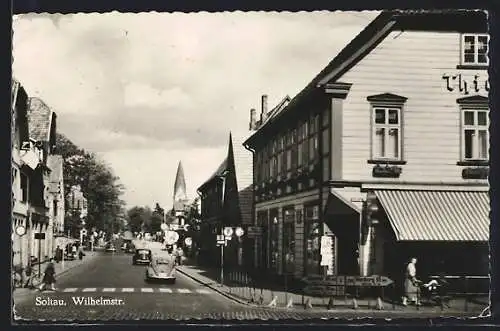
[460, 103, 490, 162]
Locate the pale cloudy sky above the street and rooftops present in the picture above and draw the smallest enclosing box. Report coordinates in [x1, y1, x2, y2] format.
[13, 12, 377, 207]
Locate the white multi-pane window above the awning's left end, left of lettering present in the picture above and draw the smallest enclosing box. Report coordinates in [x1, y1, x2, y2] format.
[372, 107, 401, 160]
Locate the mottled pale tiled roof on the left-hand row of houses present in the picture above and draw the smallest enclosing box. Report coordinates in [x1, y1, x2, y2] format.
[28, 97, 53, 142]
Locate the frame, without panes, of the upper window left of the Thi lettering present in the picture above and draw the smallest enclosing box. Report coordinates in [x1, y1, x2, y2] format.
[370, 102, 404, 161]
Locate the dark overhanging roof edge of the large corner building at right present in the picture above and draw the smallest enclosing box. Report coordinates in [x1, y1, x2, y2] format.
[245, 9, 488, 146]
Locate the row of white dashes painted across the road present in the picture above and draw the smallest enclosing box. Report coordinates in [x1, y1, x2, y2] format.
[55, 287, 213, 294]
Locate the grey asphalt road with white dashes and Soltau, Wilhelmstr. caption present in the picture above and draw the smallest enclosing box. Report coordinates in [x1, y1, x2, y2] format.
[14, 252, 486, 323]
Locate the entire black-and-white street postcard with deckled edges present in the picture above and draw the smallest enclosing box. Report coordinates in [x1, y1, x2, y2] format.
[11, 9, 490, 324]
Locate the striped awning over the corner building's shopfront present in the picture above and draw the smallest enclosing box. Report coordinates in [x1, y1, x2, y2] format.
[375, 190, 490, 241]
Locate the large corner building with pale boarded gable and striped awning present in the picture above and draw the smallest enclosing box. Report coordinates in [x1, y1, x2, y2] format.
[245, 10, 489, 284]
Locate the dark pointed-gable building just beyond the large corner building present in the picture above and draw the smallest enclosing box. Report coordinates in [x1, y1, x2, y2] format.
[197, 133, 253, 266]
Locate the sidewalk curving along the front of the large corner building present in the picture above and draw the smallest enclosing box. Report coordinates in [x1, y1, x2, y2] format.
[177, 265, 488, 316]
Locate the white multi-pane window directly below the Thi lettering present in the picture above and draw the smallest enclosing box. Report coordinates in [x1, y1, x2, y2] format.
[462, 108, 489, 160]
